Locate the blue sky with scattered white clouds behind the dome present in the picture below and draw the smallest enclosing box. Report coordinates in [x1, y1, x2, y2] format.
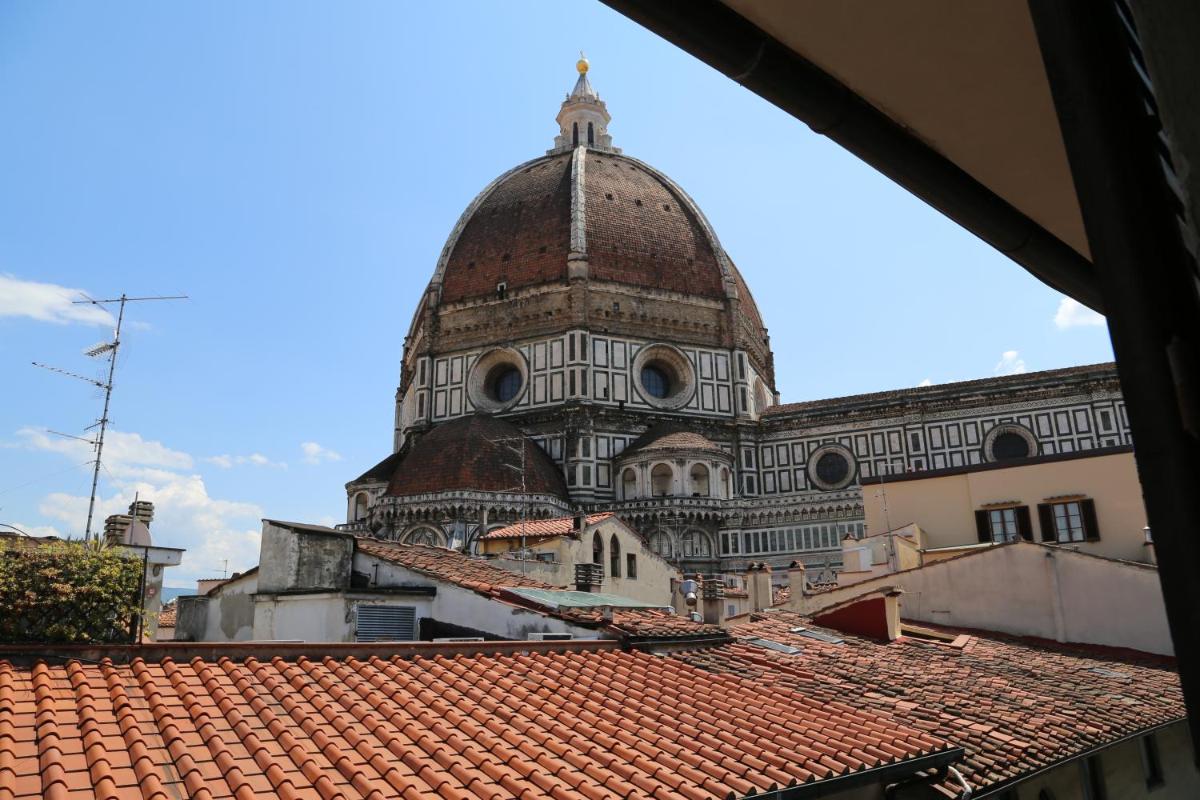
[0, 0, 1111, 584]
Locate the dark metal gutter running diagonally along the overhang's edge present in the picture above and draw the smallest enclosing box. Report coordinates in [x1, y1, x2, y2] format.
[601, 0, 1103, 312]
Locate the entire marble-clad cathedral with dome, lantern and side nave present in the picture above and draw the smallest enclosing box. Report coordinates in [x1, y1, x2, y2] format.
[342, 60, 1129, 572]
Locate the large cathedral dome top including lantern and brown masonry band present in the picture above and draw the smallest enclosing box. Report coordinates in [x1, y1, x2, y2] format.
[409, 61, 774, 386]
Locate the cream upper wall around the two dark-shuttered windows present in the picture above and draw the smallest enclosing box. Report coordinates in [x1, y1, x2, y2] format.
[863, 452, 1148, 561]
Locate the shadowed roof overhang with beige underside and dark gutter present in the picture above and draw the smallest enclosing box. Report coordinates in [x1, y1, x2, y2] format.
[604, 0, 1102, 311]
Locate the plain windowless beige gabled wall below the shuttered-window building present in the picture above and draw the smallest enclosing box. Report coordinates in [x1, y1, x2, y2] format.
[790, 542, 1174, 655]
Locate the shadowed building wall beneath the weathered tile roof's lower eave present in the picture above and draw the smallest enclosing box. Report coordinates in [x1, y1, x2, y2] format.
[1013, 722, 1200, 800]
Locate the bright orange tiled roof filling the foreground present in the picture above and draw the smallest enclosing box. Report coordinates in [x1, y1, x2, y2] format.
[0, 646, 954, 800]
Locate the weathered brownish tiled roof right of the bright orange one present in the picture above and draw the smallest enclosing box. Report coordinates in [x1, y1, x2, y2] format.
[705, 612, 1184, 794]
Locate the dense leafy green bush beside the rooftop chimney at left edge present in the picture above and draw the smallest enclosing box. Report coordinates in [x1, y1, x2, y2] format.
[0, 540, 143, 644]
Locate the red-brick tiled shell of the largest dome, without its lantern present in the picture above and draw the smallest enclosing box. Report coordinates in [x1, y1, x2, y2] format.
[433, 148, 766, 339]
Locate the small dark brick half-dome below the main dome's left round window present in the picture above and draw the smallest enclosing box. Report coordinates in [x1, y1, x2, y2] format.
[388, 414, 570, 501]
